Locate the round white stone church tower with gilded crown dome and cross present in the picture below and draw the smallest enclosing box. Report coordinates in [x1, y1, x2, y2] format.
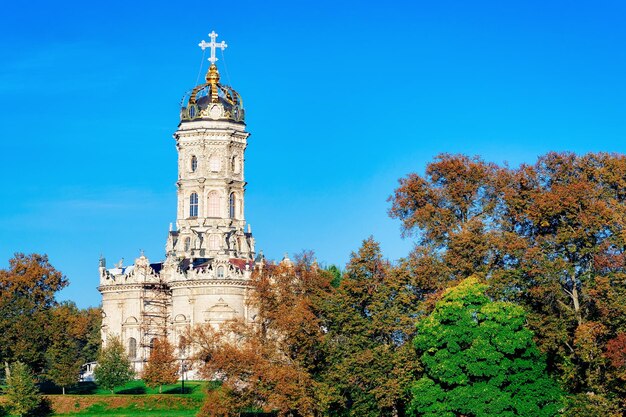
[166, 32, 254, 260]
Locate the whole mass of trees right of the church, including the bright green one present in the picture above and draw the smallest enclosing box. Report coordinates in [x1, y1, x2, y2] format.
[190, 153, 626, 417]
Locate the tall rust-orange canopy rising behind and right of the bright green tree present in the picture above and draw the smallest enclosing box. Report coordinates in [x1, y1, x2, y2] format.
[390, 152, 626, 401]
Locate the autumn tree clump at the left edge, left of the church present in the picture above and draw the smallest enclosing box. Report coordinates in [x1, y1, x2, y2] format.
[0, 253, 102, 390]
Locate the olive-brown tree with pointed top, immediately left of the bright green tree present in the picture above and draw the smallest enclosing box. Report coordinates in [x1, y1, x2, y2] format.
[318, 237, 419, 416]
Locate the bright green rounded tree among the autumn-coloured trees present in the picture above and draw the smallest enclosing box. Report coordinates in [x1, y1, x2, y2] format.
[409, 277, 562, 417]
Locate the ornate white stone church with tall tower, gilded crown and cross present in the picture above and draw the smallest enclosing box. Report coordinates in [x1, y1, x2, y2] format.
[98, 32, 264, 372]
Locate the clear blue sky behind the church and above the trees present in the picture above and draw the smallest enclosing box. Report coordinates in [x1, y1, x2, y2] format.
[0, 0, 626, 307]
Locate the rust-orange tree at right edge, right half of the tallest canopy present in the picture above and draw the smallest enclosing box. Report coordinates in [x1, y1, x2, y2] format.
[494, 153, 626, 394]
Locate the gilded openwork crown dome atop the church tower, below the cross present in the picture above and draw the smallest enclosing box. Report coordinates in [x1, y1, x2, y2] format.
[180, 64, 244, 123]
